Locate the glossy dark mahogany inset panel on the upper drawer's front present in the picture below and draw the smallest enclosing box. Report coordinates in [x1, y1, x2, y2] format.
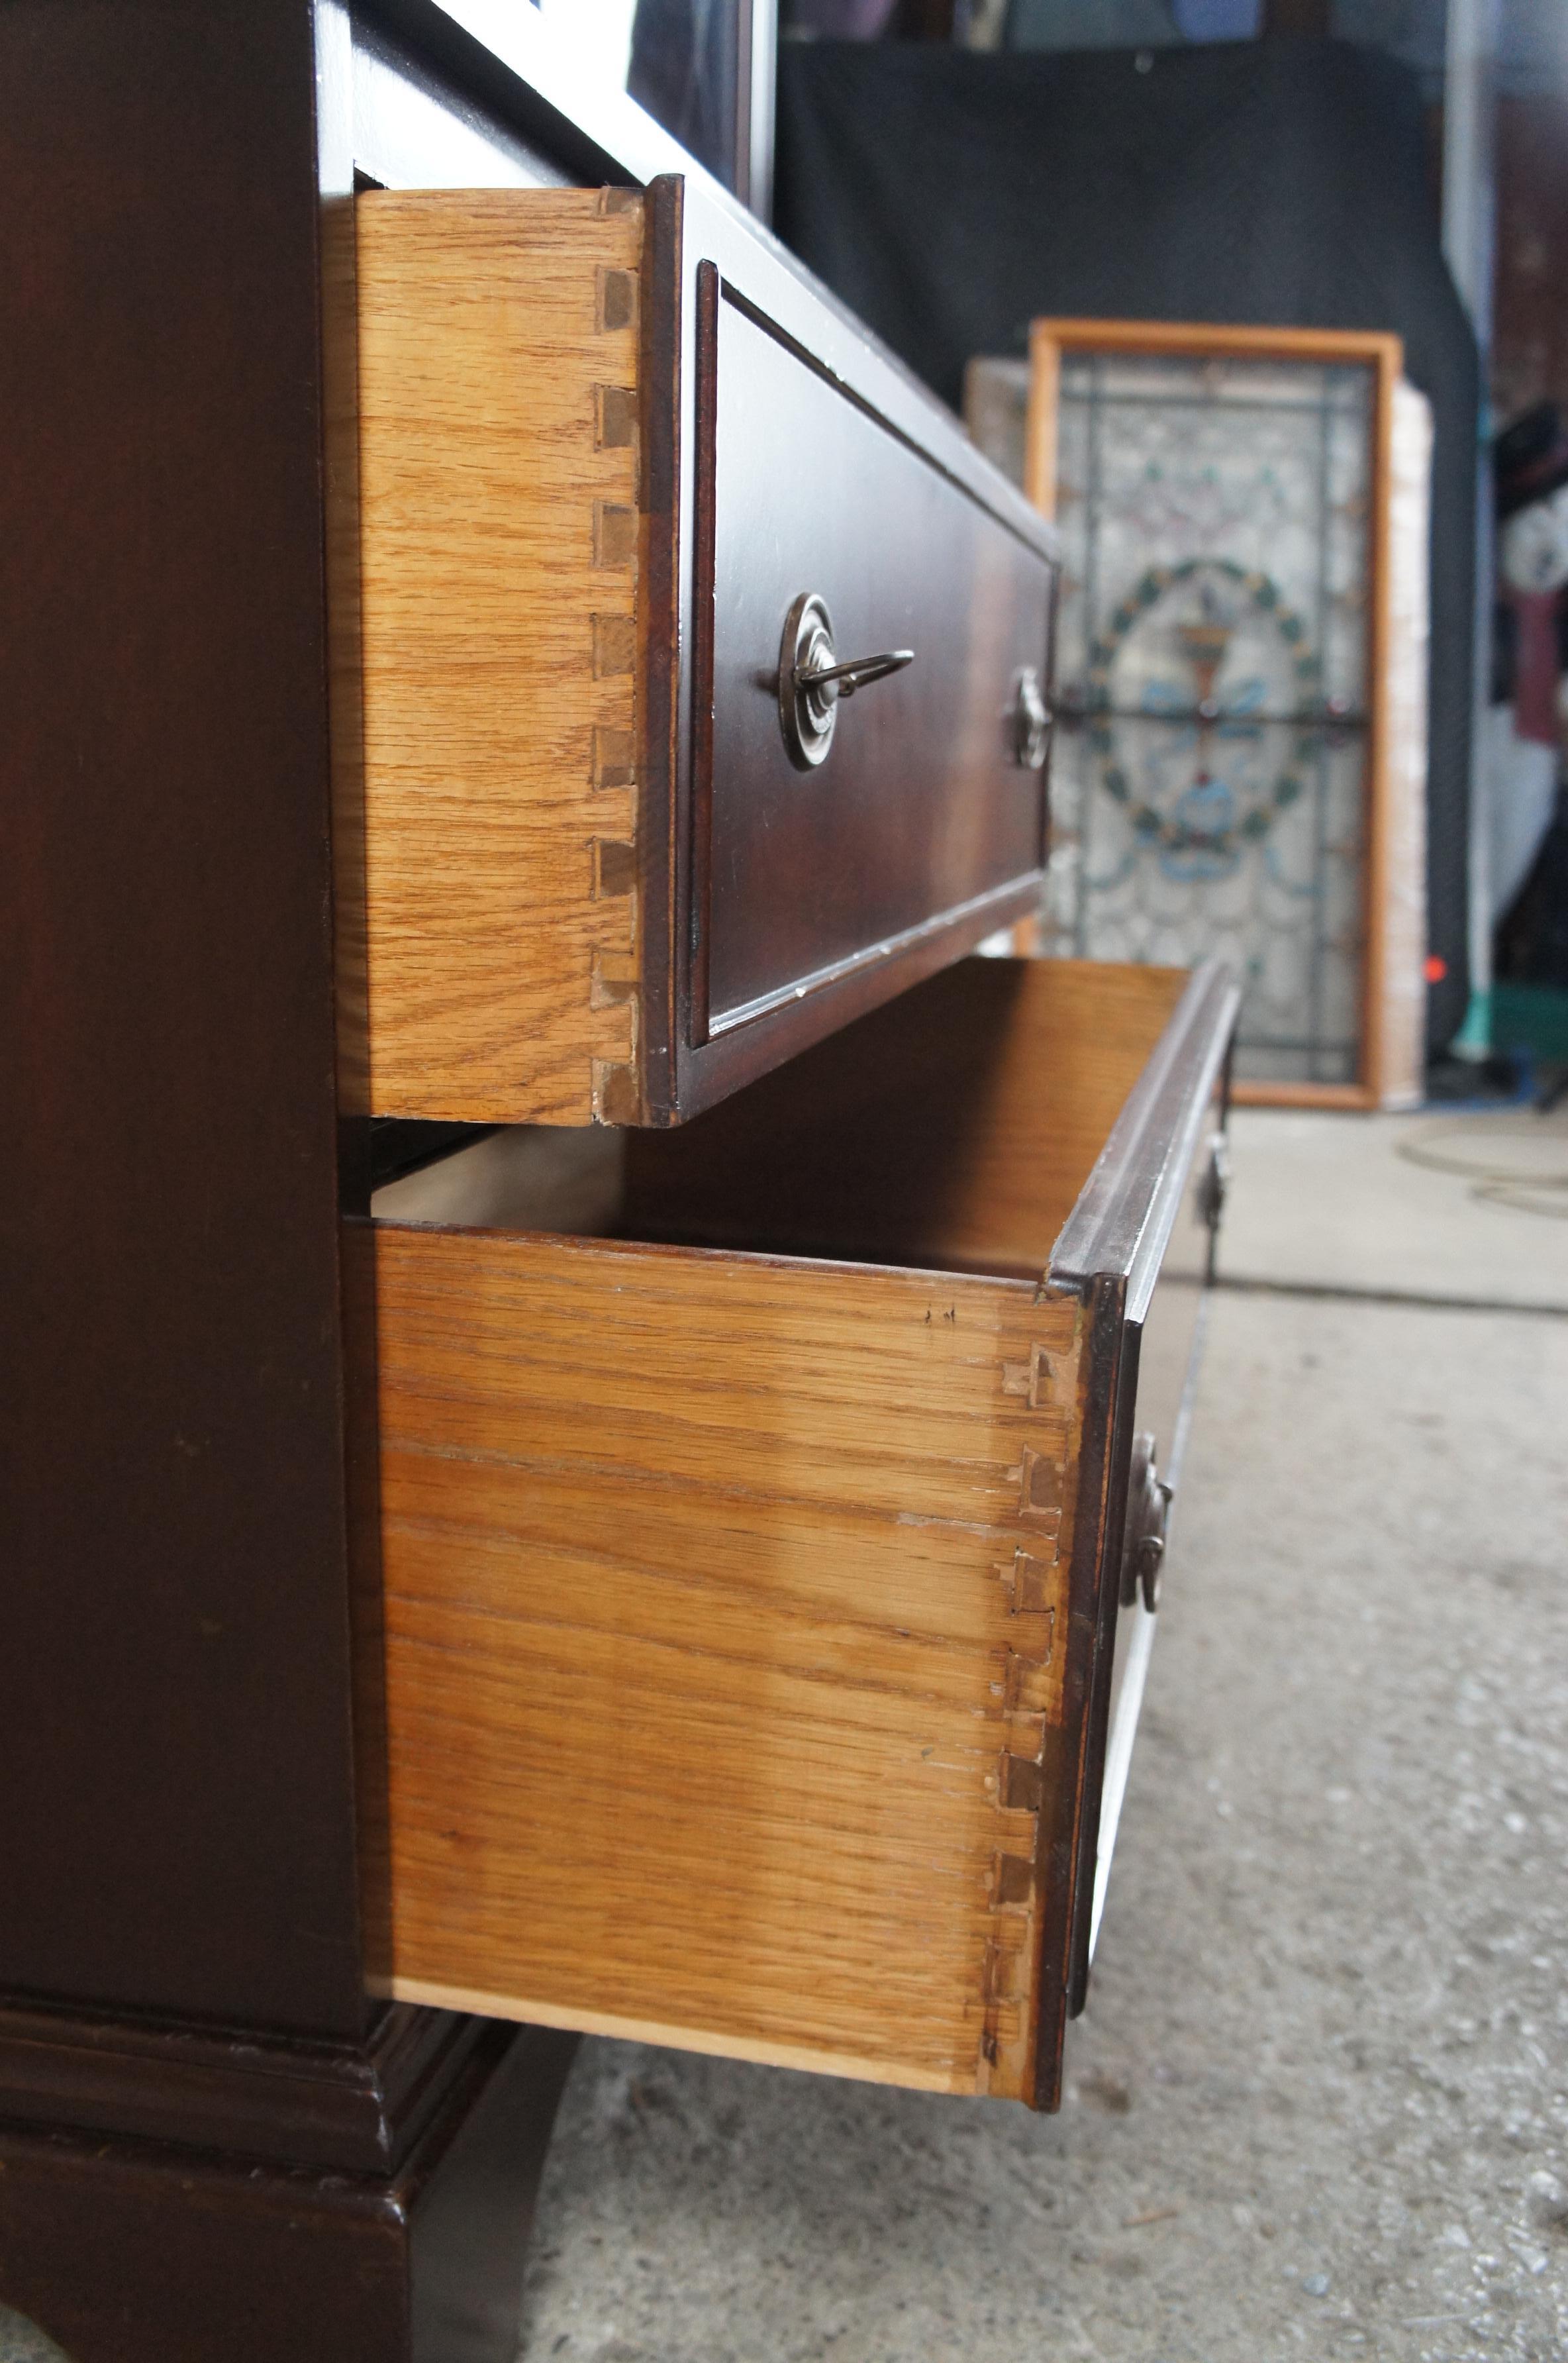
[694, 283, 1054, 1035]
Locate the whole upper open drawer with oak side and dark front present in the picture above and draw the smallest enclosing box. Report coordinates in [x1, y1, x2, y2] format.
[357, 179, 1055, 1125]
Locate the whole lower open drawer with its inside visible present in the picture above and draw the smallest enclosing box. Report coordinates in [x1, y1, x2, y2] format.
[375, 960, 1235, 2108]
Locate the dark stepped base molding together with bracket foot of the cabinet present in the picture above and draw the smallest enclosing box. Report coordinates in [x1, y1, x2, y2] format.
[0, 2004, 576, 2363]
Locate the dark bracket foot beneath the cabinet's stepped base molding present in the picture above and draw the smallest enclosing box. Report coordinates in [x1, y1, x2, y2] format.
[0, 2013, 576, 2363]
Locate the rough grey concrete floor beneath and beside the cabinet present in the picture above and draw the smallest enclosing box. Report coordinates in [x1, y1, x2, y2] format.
[522, 1111, 1568, 2363]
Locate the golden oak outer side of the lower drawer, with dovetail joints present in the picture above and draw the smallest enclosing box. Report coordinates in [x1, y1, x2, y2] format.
[378, 1227, 1079, 2096]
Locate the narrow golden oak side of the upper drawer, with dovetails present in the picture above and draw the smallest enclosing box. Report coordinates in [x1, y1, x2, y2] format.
[357, 189, 642, 1123]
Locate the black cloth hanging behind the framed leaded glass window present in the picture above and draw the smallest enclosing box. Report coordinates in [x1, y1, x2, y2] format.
[775, 40, 1478, 1047]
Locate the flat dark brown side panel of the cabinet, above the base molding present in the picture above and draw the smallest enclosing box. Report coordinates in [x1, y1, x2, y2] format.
[0, 0, 364, 2042]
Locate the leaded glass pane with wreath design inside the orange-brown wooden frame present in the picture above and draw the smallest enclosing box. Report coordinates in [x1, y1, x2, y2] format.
[968, 352, 1375, 1085]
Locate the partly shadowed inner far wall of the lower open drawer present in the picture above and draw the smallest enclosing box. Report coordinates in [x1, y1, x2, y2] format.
[623, 960, 1188, 1276]
